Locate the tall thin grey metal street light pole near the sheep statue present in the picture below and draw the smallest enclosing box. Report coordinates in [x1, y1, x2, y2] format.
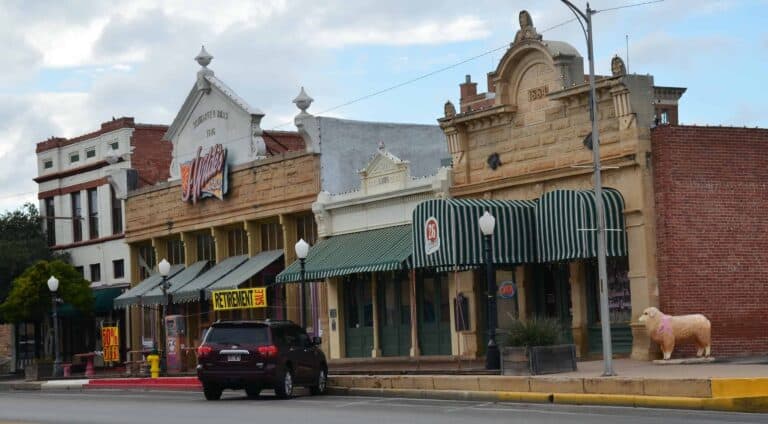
[562, 0, 616, 376]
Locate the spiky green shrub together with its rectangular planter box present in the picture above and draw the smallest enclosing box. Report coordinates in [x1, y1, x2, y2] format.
[501, 317, 576, 375]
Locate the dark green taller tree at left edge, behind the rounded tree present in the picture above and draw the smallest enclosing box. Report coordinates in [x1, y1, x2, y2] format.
[0, 203, 53, 302]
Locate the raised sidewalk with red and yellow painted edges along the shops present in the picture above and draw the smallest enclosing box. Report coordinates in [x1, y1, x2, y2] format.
[0, 358, 768, 412]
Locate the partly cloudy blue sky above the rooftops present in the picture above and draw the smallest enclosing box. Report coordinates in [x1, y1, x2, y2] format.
[0, 0, 768, 212]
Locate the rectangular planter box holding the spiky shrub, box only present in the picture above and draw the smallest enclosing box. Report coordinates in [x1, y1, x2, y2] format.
[501, 344, 576, 375]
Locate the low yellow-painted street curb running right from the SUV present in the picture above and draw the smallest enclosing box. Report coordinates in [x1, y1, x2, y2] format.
[328, 387, 768, 412]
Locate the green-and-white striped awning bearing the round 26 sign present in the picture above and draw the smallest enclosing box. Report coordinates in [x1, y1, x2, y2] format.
[413, 199, 536, 269]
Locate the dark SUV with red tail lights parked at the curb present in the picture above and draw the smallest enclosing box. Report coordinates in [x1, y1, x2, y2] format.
[197, 320, 328, 400]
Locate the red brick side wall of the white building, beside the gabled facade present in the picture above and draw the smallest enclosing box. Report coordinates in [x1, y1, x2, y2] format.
[131, 124, 173, 187]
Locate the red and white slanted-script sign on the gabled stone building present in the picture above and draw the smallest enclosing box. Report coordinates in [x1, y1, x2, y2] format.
[180, 144, 227, 203]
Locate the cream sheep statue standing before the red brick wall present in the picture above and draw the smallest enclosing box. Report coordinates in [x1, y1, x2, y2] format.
[639, 307, 712, 360]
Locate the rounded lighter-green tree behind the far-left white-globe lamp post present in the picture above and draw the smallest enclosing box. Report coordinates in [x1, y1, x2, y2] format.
[0, 259, 93, 322]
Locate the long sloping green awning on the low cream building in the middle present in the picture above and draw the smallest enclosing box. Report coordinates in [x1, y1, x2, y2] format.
[276, 225, 412, 283]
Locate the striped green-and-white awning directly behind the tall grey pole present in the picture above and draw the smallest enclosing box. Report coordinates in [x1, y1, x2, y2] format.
[536, 188, 627, 262]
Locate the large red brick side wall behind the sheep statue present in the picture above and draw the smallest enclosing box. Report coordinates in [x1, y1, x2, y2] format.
[651, 126, 768, 356]
